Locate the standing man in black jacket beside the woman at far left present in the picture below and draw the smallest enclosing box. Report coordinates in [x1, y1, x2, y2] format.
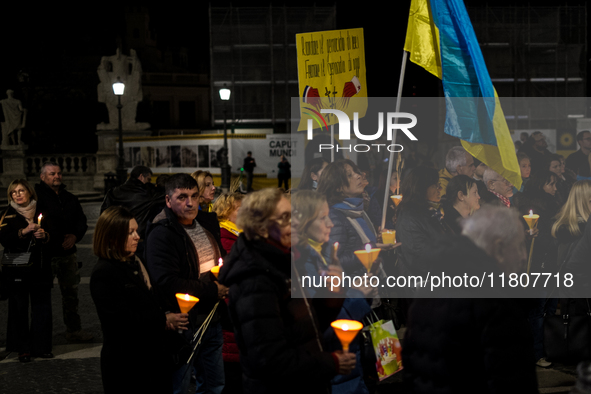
[35, 162, 93, 342]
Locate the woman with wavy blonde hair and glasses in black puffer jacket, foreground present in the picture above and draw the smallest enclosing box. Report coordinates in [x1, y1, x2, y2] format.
[219, 189, 355, 393]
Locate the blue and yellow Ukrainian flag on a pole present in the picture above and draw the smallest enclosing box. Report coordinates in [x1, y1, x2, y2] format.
[404, 0, 522, 189]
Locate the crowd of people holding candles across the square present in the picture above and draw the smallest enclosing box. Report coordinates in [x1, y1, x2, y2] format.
[0, 132, 591, 394]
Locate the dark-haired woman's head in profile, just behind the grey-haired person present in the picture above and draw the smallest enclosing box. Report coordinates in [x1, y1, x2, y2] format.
[443, 175, 480, 235]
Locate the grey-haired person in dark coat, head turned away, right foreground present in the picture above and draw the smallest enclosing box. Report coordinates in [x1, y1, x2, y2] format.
[402, 206, 538, 394]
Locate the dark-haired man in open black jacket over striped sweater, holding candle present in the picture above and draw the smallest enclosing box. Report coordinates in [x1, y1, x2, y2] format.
[146, 174, 228, 393]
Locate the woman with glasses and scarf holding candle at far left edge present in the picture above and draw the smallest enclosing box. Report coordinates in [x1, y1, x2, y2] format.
[0, 179, 53, 363]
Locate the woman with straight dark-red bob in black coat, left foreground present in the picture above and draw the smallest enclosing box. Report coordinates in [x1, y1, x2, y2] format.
[90, 206, 188, 393]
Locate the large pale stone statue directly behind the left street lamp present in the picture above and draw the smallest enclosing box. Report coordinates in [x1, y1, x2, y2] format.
[97, 49, 150, 131]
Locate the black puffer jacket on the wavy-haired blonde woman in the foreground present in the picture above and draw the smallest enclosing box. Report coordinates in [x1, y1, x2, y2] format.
[219, 234, 337, 394]
